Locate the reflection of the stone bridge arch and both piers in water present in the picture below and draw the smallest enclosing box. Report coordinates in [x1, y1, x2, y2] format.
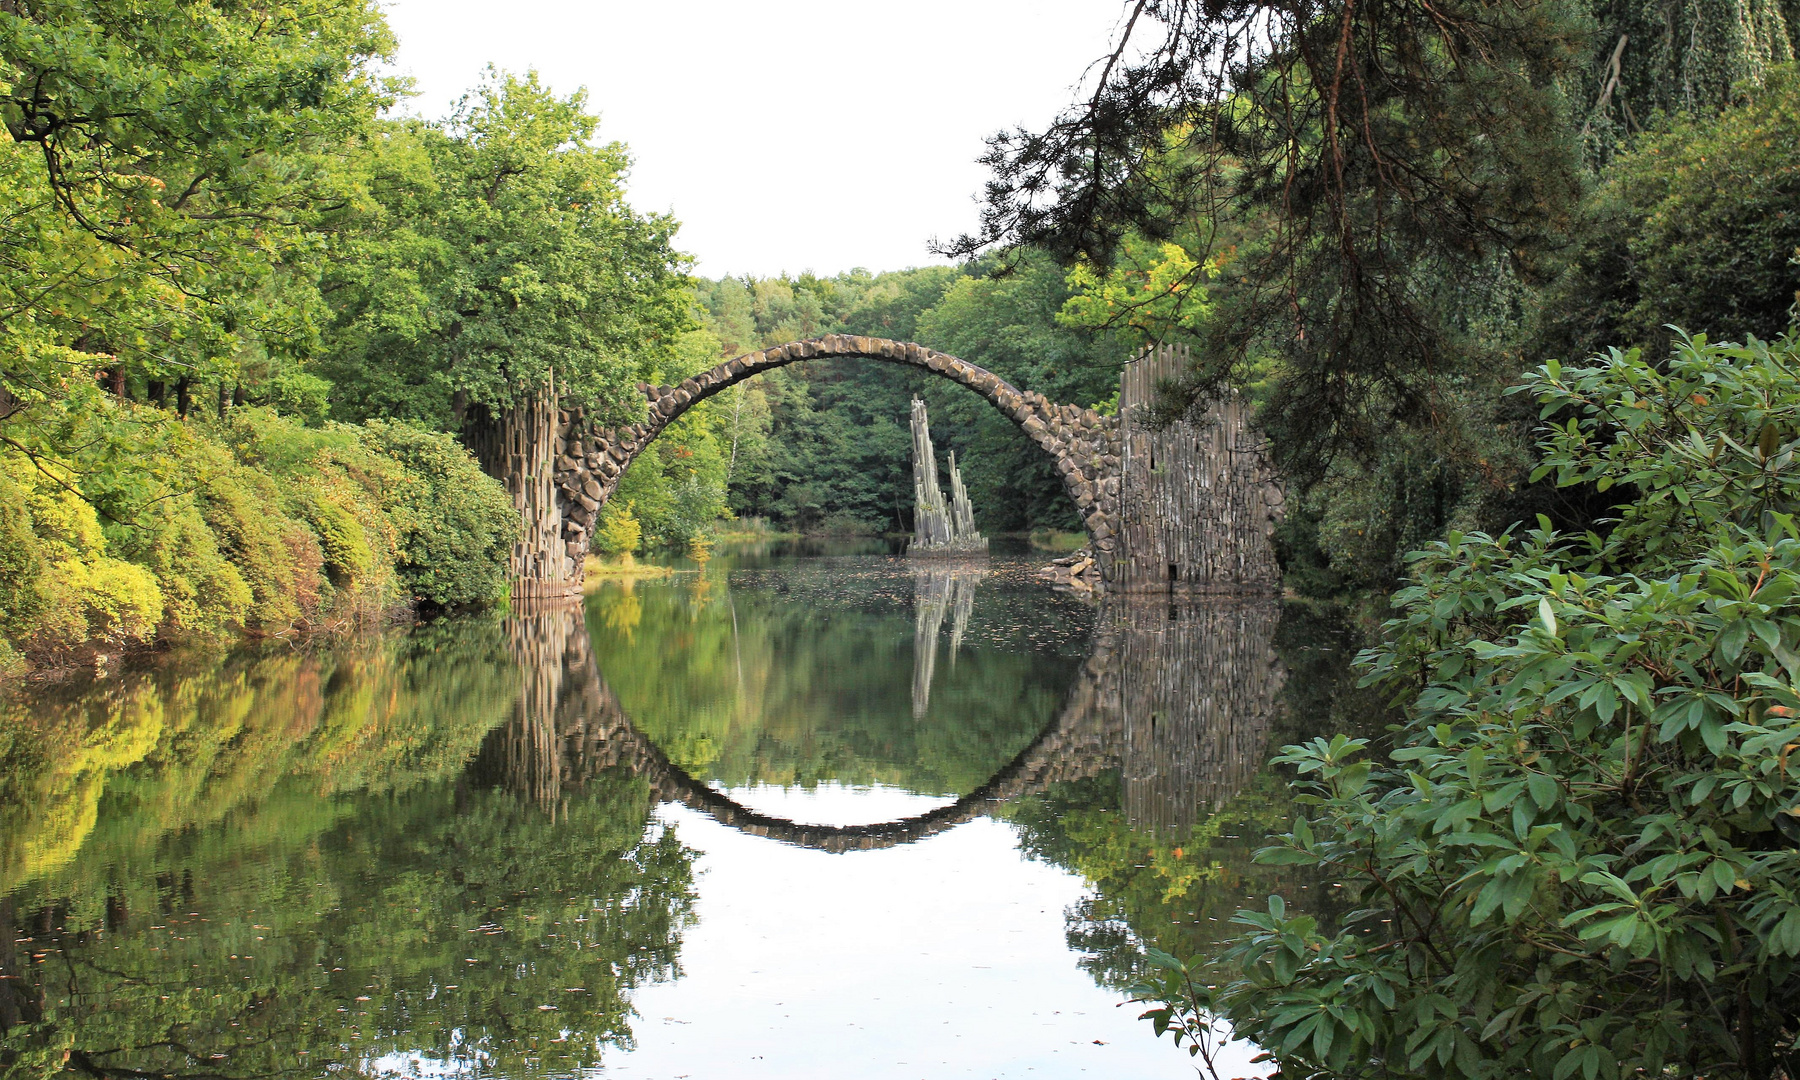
[472, 598, 1285, 851]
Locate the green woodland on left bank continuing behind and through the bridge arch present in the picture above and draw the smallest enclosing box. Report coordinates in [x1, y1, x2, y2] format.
[0, 0, 1120, 670]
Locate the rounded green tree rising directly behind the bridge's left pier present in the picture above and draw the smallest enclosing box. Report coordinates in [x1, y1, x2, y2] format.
[322, 68, 691, 428]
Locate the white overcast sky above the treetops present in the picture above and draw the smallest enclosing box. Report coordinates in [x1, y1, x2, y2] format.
[385, 0, 1121, 277]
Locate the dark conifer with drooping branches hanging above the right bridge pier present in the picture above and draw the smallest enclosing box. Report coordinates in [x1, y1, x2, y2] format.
[954, 0, 1588, 481]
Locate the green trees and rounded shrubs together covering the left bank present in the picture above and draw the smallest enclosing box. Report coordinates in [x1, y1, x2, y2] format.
[0, 0, 697, 670]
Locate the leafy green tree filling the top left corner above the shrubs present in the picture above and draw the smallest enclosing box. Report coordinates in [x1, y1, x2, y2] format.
[0, 0, 392, 489]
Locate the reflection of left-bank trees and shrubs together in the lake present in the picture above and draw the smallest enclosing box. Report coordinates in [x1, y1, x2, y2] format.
[0, 621, 693, 1078]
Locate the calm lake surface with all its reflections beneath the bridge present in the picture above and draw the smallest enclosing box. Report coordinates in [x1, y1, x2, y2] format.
[0, 544, 1341, 1078]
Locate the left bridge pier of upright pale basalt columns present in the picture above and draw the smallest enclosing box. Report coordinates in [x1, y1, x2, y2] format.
[464, 372, 583, 601]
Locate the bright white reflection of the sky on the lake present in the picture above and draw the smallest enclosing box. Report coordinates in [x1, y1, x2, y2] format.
[601, 785, 1247, 1080]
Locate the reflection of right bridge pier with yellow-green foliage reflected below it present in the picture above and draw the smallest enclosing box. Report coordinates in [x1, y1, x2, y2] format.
[1012, 598, 1354, 988]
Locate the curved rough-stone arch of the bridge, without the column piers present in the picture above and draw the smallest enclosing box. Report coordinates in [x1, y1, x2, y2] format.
[553, 333, 1120, 580]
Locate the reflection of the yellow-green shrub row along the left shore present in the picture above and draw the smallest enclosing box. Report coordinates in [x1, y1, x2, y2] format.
[0, 621, 517, 887]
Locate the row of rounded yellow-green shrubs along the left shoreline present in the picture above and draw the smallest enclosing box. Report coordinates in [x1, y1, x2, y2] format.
[0, 401, 518, 677]
